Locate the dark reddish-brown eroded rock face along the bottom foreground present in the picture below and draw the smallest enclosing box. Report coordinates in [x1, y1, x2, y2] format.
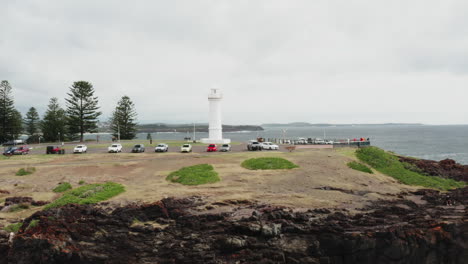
[0, 188, 468, 263]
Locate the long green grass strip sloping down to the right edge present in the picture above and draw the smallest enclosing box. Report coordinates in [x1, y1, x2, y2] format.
[356, 147, 465, 190]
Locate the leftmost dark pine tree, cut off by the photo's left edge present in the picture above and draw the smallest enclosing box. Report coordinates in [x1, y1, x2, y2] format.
[0, 80, 22, 143]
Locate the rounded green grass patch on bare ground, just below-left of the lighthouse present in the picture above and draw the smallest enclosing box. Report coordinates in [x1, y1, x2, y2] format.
[166, 164, 221, 185]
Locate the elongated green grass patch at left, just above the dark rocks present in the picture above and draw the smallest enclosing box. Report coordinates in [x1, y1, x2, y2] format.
[45, 182, 125, 209]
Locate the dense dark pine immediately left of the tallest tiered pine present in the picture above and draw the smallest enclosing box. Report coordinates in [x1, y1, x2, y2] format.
[40, 97, 66, 142]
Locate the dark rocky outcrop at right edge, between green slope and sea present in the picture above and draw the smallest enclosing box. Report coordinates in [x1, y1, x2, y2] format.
[400, 157, 468, 182]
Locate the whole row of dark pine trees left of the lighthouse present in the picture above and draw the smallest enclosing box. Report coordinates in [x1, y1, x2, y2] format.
[0, 80, 137, 143]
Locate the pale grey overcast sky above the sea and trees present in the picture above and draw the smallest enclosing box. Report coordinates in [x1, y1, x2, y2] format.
[0, 0, 468, 124]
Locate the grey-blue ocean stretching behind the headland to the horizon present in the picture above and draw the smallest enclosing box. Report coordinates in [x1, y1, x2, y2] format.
[87, 125, 468, 165]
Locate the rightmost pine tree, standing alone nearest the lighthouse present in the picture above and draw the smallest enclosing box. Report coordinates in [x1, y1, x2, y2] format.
[110, 96, 137, 139]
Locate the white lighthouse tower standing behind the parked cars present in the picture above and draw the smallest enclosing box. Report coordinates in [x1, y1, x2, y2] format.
[201, 89, 231, 144]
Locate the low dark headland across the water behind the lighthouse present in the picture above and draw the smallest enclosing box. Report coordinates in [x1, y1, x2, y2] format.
[137, 123, 263, 133]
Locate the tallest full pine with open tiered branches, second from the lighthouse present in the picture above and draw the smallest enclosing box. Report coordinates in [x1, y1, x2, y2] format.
[65, 81, 101, 142]
